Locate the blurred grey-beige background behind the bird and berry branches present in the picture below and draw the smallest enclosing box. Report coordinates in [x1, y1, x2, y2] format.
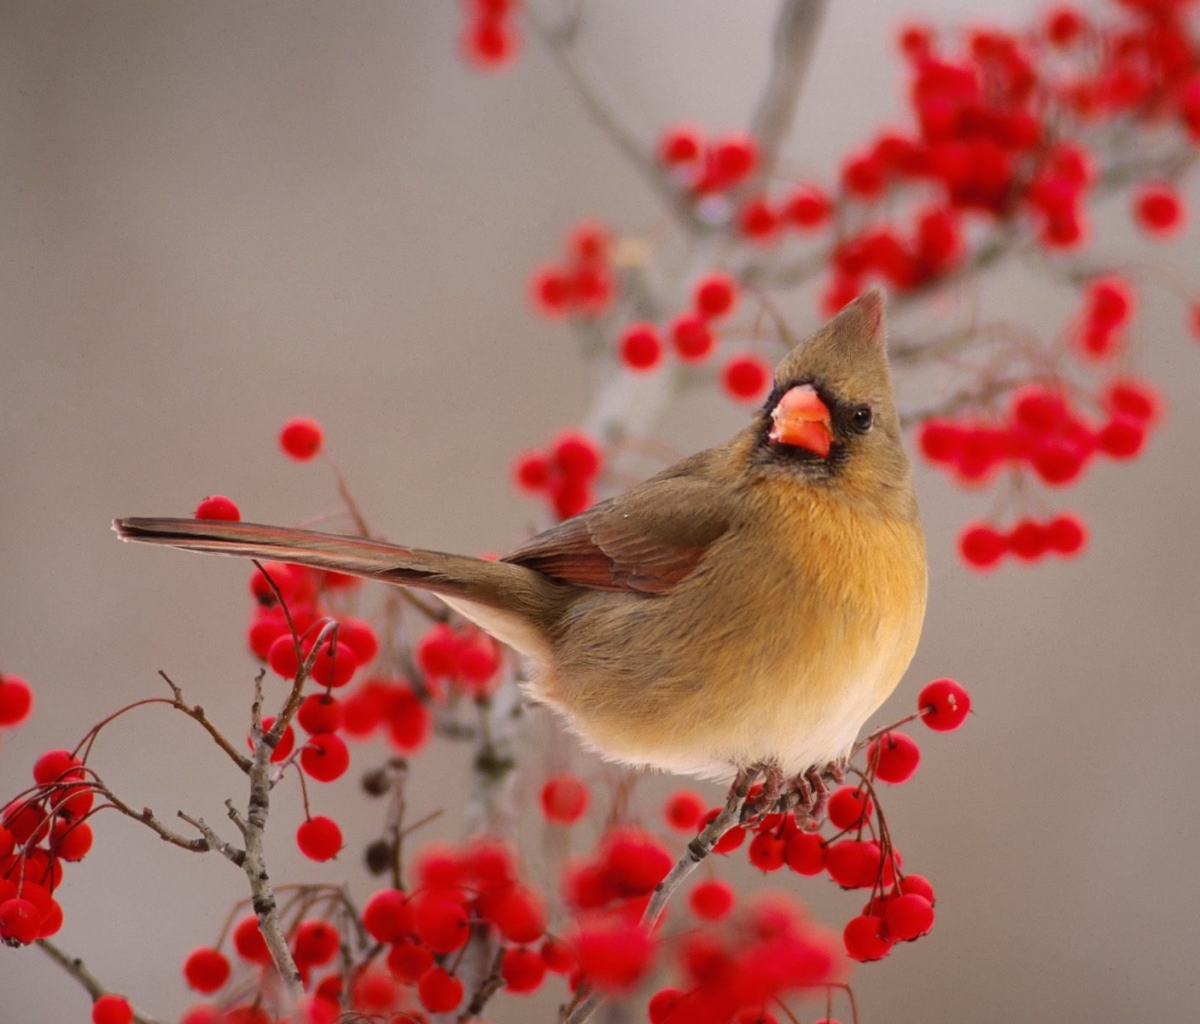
[0, 0, 1200, 1024]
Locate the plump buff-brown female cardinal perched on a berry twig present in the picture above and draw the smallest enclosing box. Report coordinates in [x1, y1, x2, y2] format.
[114, 292, 925, 778]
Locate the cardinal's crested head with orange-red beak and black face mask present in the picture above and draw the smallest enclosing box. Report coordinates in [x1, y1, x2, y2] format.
[751, 289, 911, 511]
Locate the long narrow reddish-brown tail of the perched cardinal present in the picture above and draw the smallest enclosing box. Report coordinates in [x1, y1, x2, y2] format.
[113, 517, 552, 619]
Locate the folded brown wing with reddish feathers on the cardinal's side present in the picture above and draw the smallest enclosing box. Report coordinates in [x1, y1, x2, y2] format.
[502, 477, 732, 594]
